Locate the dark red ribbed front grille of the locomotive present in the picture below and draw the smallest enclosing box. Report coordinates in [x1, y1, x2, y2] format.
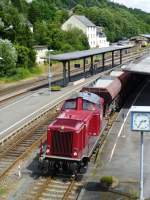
[52, 131, 73, 156]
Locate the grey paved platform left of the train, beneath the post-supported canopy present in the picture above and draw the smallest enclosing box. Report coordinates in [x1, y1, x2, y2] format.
[0, 69, 112, 143]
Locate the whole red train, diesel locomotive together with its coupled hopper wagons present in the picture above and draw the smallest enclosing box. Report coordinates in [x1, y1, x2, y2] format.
[40, 72, 142, 172]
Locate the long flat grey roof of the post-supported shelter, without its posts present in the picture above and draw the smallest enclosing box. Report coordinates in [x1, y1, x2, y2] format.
[47, 45, 133, 62]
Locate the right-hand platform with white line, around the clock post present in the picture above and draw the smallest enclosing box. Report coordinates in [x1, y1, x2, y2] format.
[79, 80, 150, 200]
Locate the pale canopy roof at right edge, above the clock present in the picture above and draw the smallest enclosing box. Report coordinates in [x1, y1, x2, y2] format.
[122, 56, 150, 74]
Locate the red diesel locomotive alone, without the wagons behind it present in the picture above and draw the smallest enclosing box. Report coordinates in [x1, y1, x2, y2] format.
[41, 92, 104, 171]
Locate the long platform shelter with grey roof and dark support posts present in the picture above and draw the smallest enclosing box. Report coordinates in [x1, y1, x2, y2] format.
[47, 45, 134, 86]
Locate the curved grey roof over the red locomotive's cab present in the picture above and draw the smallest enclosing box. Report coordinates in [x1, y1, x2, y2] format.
[71, 92, 100, 105]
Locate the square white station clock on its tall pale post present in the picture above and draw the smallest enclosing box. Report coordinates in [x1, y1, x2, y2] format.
[131, 106, 150, 200]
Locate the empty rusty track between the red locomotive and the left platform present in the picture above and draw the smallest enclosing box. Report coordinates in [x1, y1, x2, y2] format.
[0, 107, 56, 181]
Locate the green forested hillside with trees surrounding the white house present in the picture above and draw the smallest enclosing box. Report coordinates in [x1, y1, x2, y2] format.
[0, 0, 150, 77]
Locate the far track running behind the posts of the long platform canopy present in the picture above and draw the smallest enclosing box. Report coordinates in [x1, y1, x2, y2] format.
[0, 47, 148, 105]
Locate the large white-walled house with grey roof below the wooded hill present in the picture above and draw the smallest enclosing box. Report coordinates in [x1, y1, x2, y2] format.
[61, 15, 109, 48]
